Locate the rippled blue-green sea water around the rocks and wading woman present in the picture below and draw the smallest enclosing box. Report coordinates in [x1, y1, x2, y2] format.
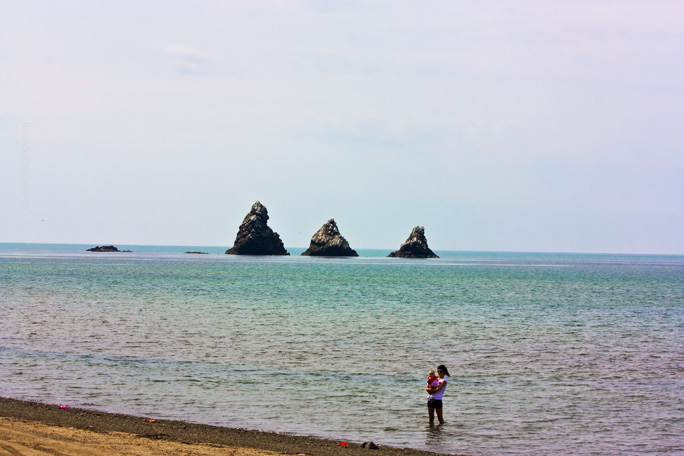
[0, 244, 684, 455]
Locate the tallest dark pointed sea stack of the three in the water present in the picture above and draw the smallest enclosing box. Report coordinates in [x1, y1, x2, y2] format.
[226, 201, 289, 255]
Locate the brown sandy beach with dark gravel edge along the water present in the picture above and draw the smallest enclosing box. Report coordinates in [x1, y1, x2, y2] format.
[0, 398, 462, 456]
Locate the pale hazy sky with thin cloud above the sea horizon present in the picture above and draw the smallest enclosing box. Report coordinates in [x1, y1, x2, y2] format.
[0, 0, 684, 254]
